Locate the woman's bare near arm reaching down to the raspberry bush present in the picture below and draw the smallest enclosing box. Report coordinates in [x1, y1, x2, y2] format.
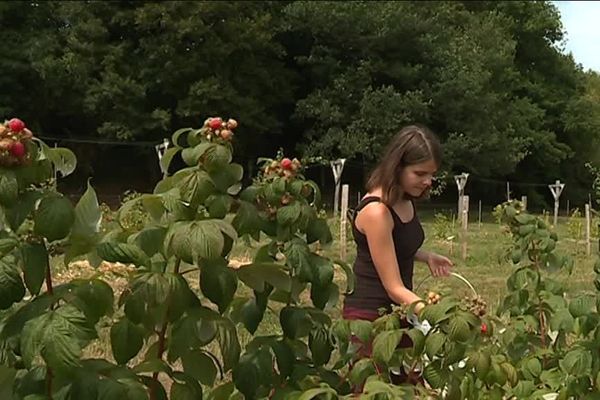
[356, 203, 423, 313]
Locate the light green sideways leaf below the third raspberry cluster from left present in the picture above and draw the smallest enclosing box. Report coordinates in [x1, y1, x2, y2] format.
[235, 262, 292, 292]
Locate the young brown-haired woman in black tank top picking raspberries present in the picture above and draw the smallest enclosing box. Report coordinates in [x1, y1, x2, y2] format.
[343, 125, 452, 384]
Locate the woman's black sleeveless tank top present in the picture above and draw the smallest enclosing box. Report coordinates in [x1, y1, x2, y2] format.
[344, 196, 425, 311]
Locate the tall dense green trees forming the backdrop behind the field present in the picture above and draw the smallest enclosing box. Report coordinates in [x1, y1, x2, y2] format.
[0, 1, 600, 203]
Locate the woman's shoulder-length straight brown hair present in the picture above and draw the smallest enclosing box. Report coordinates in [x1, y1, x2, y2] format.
[366, 125, 442, 206]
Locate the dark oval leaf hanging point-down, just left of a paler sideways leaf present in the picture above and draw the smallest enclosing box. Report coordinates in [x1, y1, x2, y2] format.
[200, 259, 237, 313]
